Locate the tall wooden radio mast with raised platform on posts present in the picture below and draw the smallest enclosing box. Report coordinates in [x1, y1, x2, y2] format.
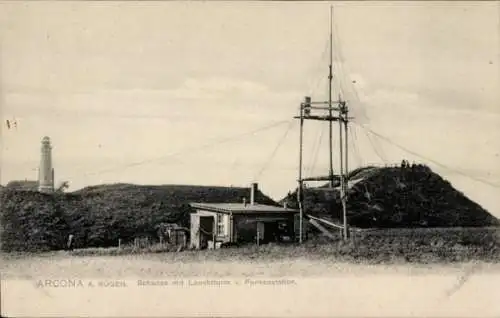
[294, 6, 352, 243]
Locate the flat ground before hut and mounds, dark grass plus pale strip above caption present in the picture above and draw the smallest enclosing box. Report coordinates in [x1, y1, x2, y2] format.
[1, 228, 500, 278]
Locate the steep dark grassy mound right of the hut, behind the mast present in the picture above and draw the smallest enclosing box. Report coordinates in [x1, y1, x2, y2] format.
[284, 165, 500, 228]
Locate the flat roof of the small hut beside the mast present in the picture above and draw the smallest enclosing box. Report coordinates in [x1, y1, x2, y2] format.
[190, 203, 299, 214]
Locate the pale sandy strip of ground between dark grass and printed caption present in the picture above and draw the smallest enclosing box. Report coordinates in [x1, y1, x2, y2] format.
[0, 254, 500, 278]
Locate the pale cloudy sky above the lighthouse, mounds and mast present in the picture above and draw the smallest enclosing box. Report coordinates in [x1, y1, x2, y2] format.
[0, 1, 500, 217]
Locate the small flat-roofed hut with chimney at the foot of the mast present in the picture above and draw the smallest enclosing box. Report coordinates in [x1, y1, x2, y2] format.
[190, 183, 300, 249]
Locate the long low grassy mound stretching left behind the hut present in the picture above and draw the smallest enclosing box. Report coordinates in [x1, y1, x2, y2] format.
[0, 184, 276, 251]
